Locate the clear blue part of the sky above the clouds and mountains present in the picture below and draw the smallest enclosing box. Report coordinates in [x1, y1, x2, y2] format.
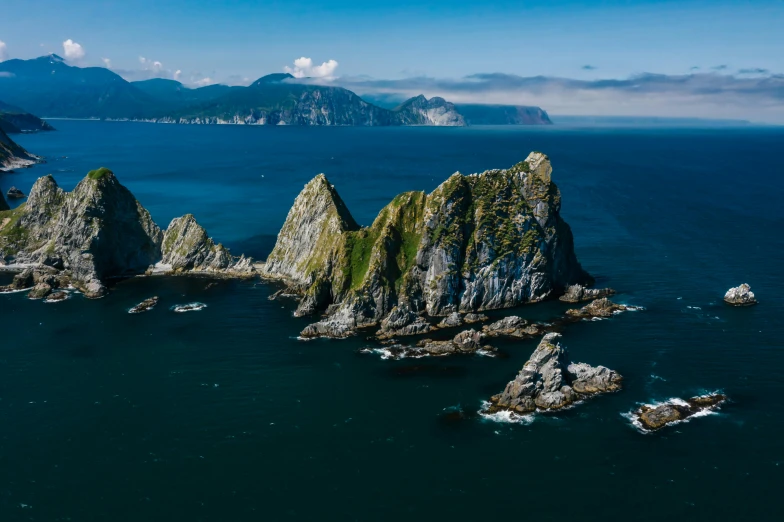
[0, 0, 784, 119]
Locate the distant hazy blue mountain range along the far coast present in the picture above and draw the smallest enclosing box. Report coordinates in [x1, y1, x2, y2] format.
[0, 54, 552, 125]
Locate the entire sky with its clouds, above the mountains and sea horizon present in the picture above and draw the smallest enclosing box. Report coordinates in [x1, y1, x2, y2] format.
[0, 0, 784, 123]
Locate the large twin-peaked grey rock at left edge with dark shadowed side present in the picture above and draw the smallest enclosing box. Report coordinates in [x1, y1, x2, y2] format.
[0, 169, 162, 296]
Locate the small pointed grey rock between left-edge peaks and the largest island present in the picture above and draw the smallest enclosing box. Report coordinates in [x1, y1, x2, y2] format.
[161, 214, 255, 276]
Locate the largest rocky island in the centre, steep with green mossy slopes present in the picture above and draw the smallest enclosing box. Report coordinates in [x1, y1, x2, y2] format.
[262, 152, 590, 337]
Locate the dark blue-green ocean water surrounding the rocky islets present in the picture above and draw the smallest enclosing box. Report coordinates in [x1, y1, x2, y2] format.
[0, 121, 784, 521]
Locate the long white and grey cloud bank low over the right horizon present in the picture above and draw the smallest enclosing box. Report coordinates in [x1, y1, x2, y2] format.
[320, 70, 784, 123]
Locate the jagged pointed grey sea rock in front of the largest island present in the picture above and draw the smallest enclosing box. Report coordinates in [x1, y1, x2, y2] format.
[484, 333, 622, 414]
